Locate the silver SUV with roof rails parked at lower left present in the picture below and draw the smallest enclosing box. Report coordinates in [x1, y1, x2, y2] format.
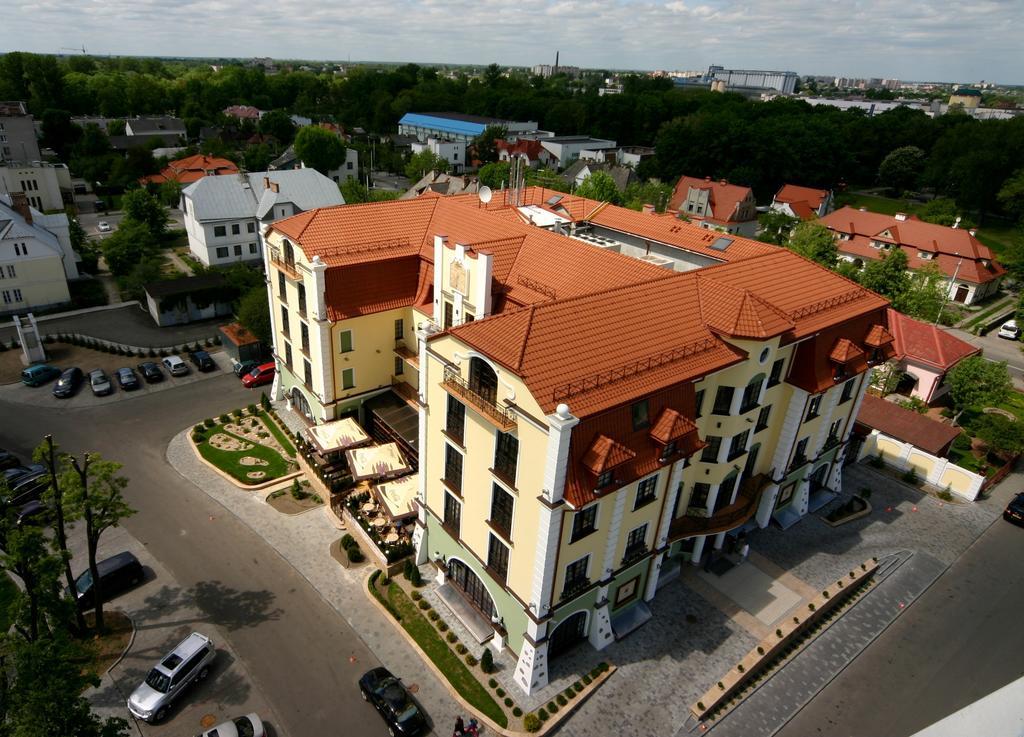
[128, 633, 217, 724]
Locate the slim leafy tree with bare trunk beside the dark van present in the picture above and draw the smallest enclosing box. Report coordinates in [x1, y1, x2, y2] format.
[61, 452, 135, 632]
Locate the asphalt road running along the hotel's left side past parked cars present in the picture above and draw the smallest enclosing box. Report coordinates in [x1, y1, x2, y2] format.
[0, 376, 386, 737]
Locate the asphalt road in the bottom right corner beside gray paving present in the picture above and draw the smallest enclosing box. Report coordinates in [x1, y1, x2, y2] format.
[776, 507, 1024, 737]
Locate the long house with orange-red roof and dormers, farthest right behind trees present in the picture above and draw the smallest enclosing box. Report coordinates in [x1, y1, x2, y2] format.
[821, 207, 1007, 304]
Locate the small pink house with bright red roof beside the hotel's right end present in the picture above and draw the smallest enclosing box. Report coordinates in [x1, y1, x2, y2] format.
[888, 307, 981, 404]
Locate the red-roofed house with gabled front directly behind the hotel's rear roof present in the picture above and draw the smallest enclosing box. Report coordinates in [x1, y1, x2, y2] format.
[669, 175, 758, 237]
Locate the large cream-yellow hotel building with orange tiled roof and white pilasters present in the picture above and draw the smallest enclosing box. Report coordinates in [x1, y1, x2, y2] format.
[265, 187, 892, 693]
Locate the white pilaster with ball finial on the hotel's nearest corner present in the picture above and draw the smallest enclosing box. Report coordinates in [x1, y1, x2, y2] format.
[528, 404, 580, 616]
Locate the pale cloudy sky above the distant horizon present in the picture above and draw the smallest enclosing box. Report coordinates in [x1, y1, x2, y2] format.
[0, 0, 1024, 84]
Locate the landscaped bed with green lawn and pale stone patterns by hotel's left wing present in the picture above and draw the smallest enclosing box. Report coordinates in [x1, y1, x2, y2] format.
[191, 404, 298, 486]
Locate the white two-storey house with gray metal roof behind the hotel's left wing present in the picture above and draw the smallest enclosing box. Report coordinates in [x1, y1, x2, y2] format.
[181, 169, 345, 266]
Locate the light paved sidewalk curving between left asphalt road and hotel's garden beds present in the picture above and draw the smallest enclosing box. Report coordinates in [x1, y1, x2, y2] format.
[167, 425, 466, 734]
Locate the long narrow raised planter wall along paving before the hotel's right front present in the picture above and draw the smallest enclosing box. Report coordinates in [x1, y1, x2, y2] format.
[690, 559, 879, 720]
